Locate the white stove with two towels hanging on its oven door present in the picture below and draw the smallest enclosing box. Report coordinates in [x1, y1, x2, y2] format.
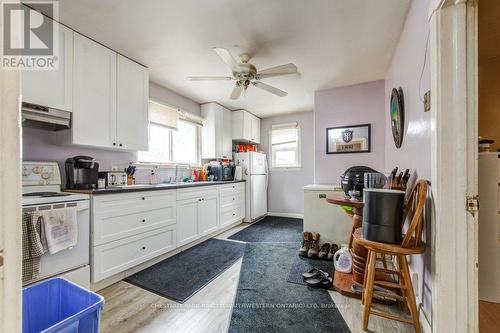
[22, 162, 90, 288]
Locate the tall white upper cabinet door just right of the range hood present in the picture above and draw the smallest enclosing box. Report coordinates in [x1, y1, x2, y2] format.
[72, 33, 116, 147]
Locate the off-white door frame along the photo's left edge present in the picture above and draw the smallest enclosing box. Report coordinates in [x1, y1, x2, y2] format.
[0, 0, 22, 332]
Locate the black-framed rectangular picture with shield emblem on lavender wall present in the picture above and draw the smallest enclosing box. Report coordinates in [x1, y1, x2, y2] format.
[326, 124, 371, 154]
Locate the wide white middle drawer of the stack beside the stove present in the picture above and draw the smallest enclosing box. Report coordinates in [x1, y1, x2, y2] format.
[92, 205, 176, 245]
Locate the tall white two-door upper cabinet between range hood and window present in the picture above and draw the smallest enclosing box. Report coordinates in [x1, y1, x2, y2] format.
[65, 32, 149, 151]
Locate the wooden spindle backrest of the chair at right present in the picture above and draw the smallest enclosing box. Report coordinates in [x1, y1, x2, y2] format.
[401, 180, 429, 248]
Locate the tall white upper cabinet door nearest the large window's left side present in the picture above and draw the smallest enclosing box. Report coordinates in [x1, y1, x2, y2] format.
[116, 55, 149, 151]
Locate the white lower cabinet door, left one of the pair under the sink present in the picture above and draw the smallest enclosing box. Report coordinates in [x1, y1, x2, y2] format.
[177, 199, 199, 246]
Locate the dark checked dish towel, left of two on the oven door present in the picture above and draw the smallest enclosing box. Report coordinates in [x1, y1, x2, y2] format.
[22, 212, 45, 283]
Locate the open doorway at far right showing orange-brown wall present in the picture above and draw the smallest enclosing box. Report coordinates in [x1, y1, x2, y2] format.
[477, 0, 500, 333]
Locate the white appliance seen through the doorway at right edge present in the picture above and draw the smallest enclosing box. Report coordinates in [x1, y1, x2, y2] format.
[478, 153, 500, 303]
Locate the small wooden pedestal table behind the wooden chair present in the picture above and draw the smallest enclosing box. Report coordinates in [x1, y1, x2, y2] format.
[326, 193, 367, 298]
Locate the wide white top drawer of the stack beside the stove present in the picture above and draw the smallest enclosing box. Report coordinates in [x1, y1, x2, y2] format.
[92, 190, 176, 216]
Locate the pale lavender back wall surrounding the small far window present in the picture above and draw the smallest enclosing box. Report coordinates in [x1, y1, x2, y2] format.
[259, 112, 314, 214]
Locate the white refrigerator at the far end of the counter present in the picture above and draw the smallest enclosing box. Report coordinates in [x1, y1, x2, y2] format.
[234, 151, 268, 222]
